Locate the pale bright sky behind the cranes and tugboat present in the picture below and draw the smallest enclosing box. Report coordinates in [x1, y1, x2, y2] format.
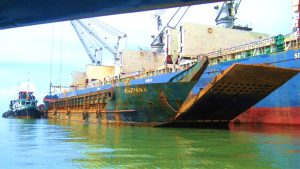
[0, 0, 292, 114]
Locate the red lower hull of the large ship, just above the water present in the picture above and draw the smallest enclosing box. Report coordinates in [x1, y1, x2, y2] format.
[232, 107, 300, 125]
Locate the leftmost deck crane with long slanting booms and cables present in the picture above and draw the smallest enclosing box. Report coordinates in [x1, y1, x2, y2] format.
[71, 18, 127, 66]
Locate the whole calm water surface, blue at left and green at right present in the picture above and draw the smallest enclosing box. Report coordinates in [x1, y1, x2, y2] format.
[0, 118, 300, 169]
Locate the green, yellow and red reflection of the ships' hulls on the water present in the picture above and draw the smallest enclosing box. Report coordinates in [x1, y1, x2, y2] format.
[51, 121, 300, 168]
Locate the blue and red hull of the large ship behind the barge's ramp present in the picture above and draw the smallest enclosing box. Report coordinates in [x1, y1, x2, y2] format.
[194, 50, 300, 124]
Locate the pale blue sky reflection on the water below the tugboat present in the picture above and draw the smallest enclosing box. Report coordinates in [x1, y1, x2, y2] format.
[0, 119, 80, 169]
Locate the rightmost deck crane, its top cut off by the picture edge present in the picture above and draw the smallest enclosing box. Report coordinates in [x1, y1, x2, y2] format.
[215, 0, 242, 28]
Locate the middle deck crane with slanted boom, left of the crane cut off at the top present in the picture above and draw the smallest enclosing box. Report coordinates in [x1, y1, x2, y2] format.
[151, 6, 190, 52]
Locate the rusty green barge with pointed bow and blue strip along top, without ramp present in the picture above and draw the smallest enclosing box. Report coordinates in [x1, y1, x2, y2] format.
[45, 58, 208, 126]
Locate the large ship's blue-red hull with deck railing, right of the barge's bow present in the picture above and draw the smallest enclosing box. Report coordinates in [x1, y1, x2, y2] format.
[197, 32, 300, 125]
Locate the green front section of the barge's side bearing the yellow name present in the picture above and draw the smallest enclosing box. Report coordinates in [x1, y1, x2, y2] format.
[106, 82, 196, 123]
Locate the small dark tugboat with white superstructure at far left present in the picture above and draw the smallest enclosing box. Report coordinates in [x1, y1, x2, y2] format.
[2, 91, 42, 118]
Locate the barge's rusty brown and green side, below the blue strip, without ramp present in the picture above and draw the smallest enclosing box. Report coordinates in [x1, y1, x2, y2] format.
[47, 82, 196, 126]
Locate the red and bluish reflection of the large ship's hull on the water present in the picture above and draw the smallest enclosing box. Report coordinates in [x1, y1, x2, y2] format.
[230, 124, 300, 169]
